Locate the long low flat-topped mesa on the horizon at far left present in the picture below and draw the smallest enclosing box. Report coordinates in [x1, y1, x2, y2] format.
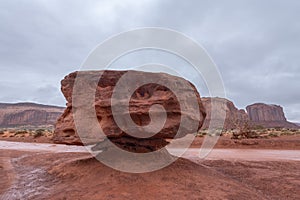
[0, 103, 64, 128]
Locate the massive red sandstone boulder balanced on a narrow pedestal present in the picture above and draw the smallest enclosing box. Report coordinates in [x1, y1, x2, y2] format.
[53, 70, 206, 152]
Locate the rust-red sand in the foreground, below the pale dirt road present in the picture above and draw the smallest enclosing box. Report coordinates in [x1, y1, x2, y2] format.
[0, 141, 300, 200]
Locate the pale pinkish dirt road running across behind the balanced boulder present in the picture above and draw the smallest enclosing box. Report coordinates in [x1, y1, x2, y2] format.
[0, 141, 300, 161]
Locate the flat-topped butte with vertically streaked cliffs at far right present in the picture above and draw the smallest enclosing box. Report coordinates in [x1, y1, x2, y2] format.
[246, 103, 299, 128]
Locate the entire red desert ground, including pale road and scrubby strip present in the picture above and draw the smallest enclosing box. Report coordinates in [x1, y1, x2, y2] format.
[0, 129, 300, 200]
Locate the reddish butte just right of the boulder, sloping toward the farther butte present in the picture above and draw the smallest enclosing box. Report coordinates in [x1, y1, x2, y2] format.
[201, 97, 249, 129]
